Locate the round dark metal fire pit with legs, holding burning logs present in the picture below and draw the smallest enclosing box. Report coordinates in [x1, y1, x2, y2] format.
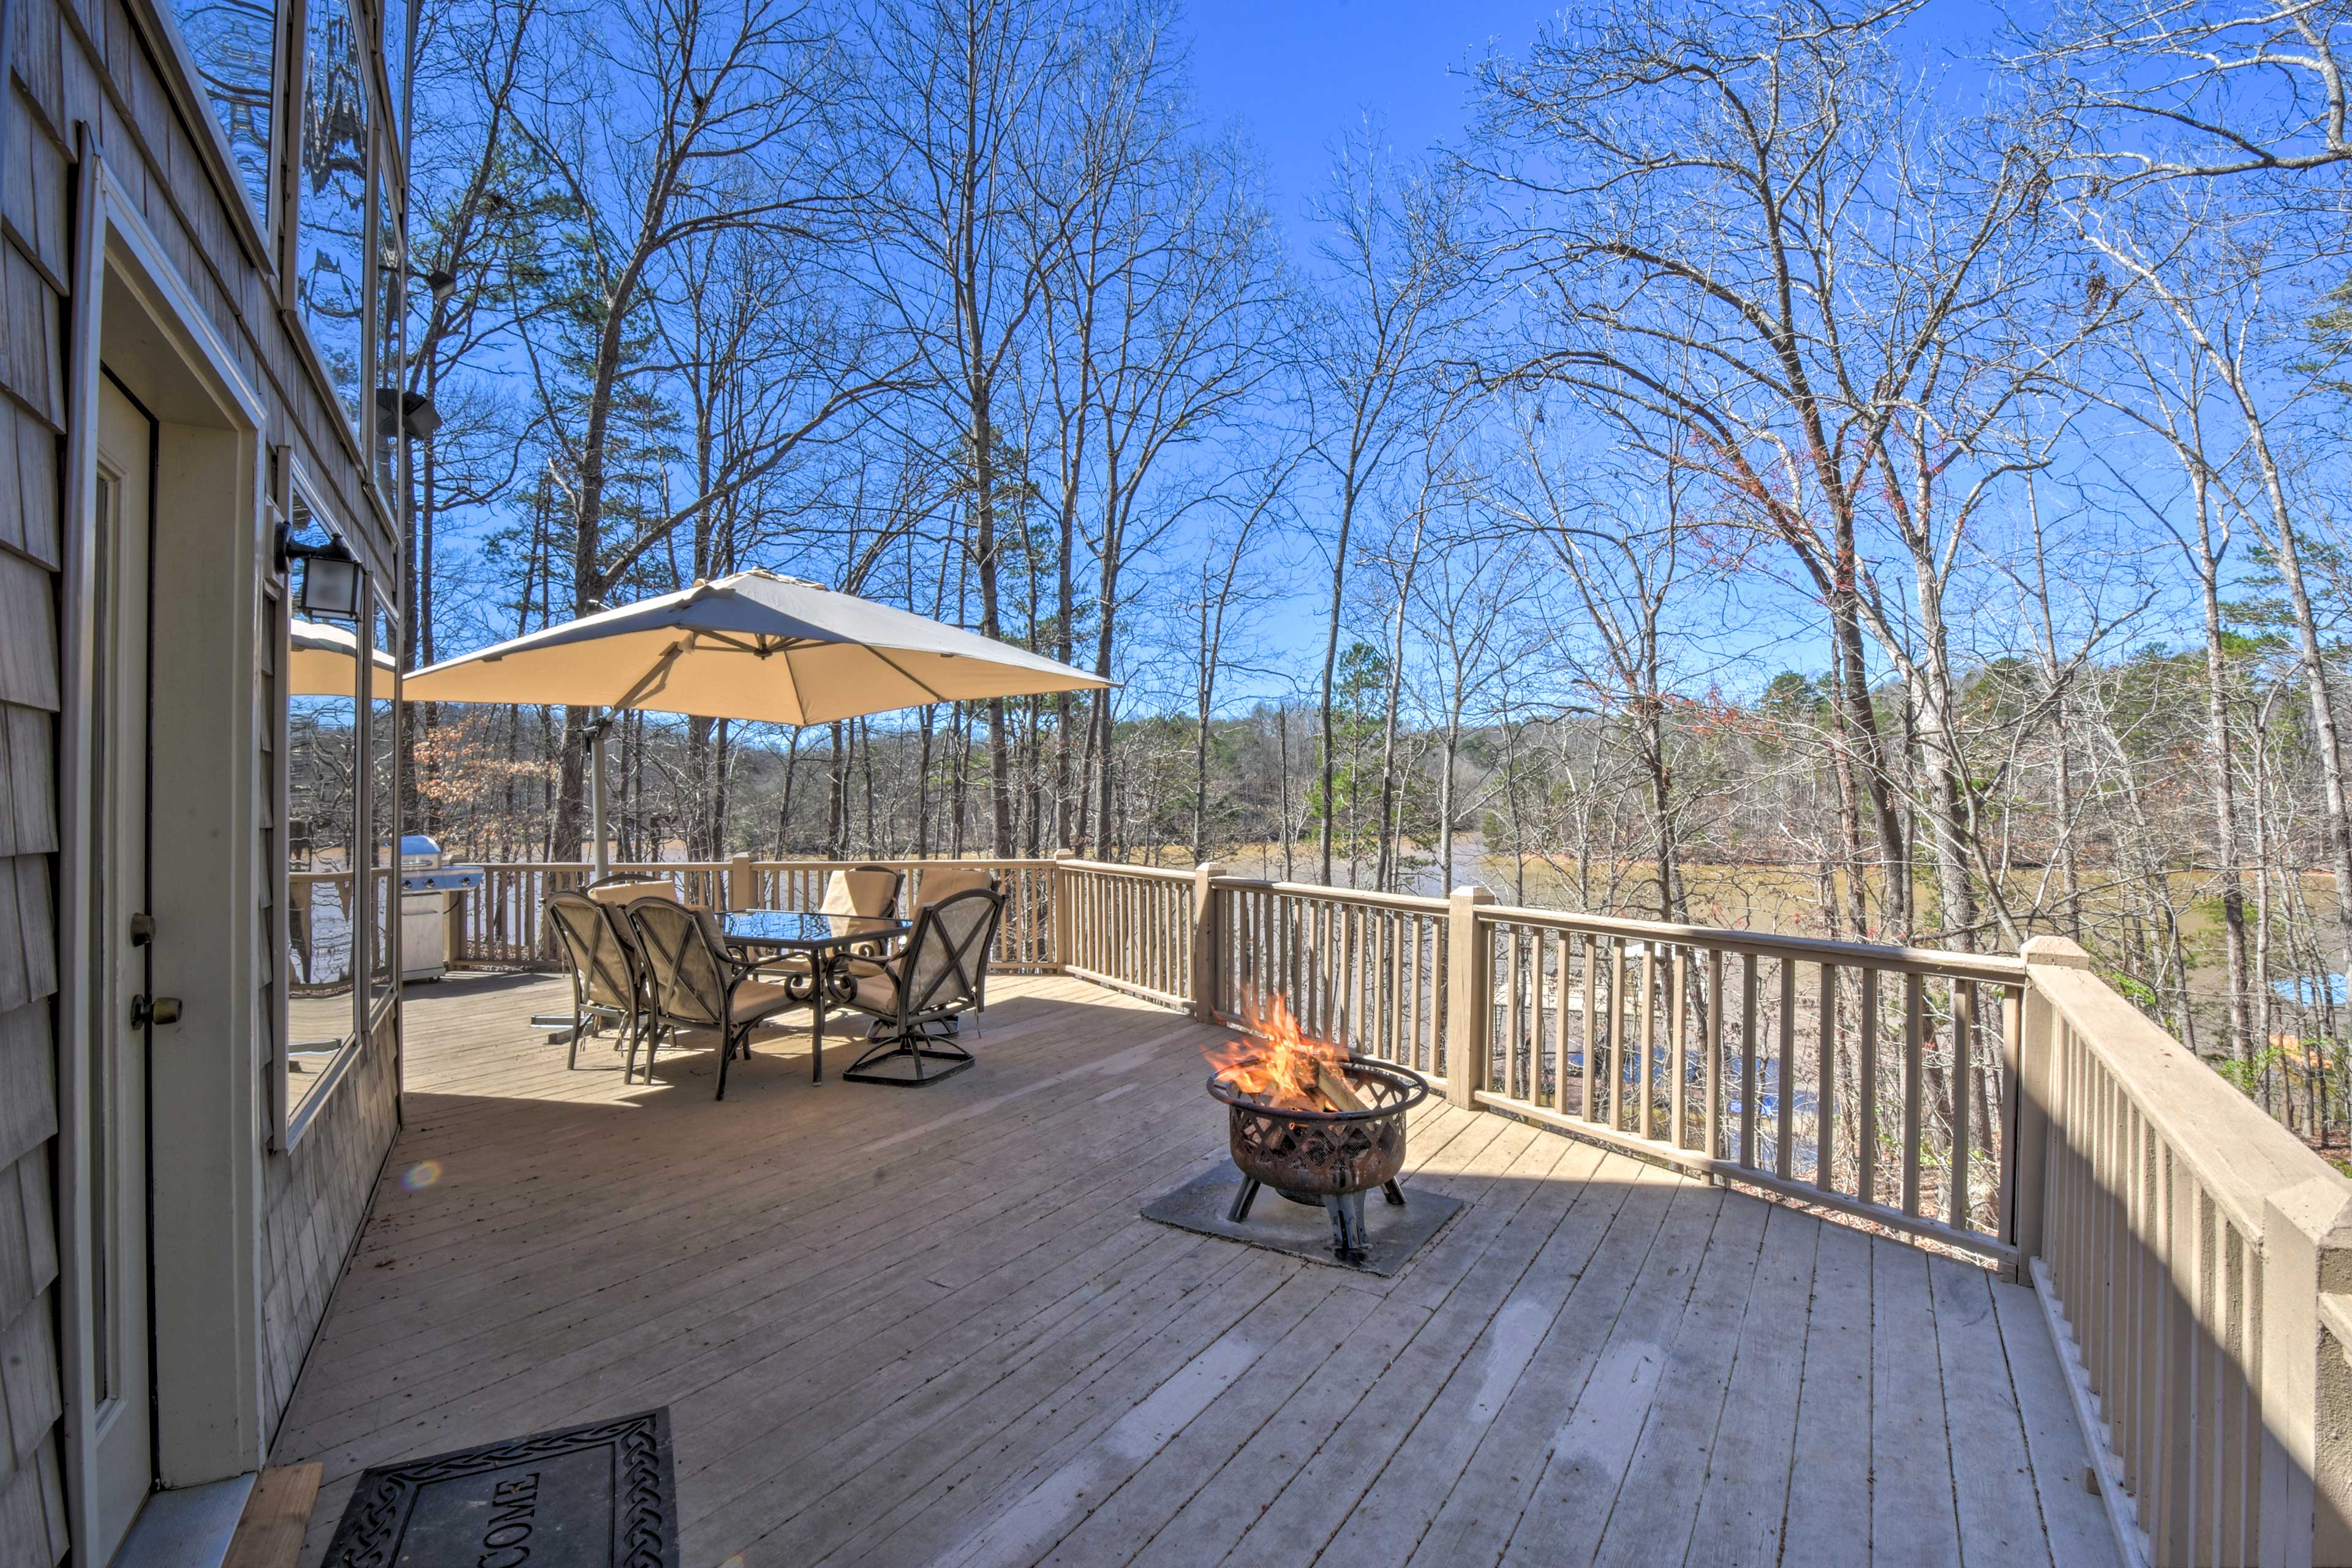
[1209, 1055, 1430, 1262]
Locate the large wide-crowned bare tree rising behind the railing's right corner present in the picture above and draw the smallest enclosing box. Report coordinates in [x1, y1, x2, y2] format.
[1487, 2, 2079, 933]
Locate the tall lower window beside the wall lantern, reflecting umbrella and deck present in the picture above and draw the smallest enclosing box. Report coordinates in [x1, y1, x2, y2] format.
[287, 499, 364, 1114]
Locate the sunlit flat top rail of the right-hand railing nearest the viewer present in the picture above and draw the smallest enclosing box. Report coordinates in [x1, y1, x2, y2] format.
[2032, 964, 2352, 1237]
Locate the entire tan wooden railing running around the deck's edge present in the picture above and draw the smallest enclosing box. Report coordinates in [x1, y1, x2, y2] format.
[423, 856, 2352, 1568]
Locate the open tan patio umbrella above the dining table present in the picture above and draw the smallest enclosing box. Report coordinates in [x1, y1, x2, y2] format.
[404, 571, 1110, 877]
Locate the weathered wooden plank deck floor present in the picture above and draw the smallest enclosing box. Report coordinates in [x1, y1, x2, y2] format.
[271, 978, 2117, 1568]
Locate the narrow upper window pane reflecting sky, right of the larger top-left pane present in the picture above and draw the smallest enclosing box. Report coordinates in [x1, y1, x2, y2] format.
[294, 0, 369, 430]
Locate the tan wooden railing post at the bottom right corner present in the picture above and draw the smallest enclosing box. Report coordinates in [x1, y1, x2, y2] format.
[2260, 1175, 2352, 1568]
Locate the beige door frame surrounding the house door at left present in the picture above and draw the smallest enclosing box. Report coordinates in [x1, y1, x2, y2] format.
[56, 124, 266, 1542]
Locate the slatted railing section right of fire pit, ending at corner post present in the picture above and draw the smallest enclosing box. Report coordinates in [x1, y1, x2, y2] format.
[1451, 895, 2025, 1267]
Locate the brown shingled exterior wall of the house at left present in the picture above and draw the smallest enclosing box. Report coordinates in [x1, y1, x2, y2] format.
[0, 0, 398, 1568]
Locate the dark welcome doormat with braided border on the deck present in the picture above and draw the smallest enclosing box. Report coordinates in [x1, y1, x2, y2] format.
[325, 1408, 677, 1568]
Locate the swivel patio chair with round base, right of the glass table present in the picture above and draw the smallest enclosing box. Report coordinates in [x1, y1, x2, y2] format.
[842, 886, 1005, 1088]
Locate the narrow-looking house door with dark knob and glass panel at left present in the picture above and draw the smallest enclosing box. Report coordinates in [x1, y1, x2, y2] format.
[85, 379, 155, 1563]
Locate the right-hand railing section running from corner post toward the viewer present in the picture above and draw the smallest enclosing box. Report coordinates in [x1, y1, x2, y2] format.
[2018, 938, 2352, 1563]
